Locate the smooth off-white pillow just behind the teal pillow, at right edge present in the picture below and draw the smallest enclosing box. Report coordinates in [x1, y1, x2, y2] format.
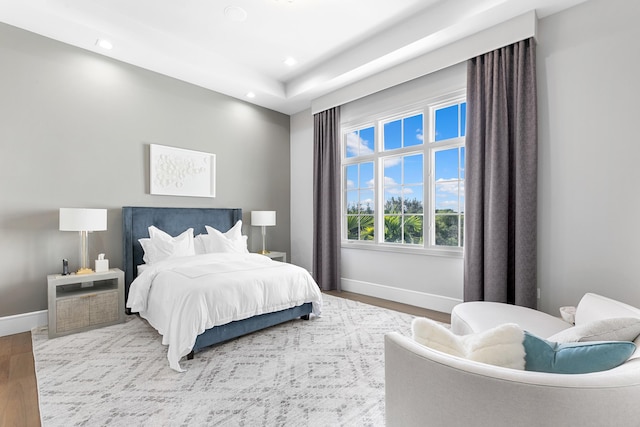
[548, 317, 640, 343]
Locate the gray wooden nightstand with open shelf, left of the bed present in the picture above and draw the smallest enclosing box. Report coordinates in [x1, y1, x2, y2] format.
[47, 268, 124, 338]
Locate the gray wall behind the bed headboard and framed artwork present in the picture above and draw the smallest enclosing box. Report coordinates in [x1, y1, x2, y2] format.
[0, 24, 290, 317]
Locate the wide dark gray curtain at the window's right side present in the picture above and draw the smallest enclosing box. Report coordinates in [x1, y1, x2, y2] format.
[464, 38, 538, 308]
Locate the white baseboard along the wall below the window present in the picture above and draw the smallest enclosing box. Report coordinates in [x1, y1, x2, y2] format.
[342, 278, 462, 313]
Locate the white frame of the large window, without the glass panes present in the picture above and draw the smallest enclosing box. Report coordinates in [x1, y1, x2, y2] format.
[340, 89, 466, 257]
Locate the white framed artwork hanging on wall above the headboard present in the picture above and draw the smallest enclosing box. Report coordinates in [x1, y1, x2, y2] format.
[149, 144, 216, 197]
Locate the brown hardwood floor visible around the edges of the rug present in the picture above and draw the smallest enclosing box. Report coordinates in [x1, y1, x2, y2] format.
[0, 291, 451, 427]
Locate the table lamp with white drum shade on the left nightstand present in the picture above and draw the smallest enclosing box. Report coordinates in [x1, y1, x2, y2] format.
[60, 208, 107, 274]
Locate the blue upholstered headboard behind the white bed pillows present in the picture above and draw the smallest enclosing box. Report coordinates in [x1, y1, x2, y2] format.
[122, 206, 242, 301]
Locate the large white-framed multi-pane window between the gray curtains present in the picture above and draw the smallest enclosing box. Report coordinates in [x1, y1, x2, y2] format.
[342, 96, 466, 249]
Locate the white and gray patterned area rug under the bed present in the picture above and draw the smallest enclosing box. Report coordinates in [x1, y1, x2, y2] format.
[32, 295, 422, 427]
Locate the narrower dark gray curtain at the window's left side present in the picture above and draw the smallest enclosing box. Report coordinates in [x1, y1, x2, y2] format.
[313, 107, 341, 291]
